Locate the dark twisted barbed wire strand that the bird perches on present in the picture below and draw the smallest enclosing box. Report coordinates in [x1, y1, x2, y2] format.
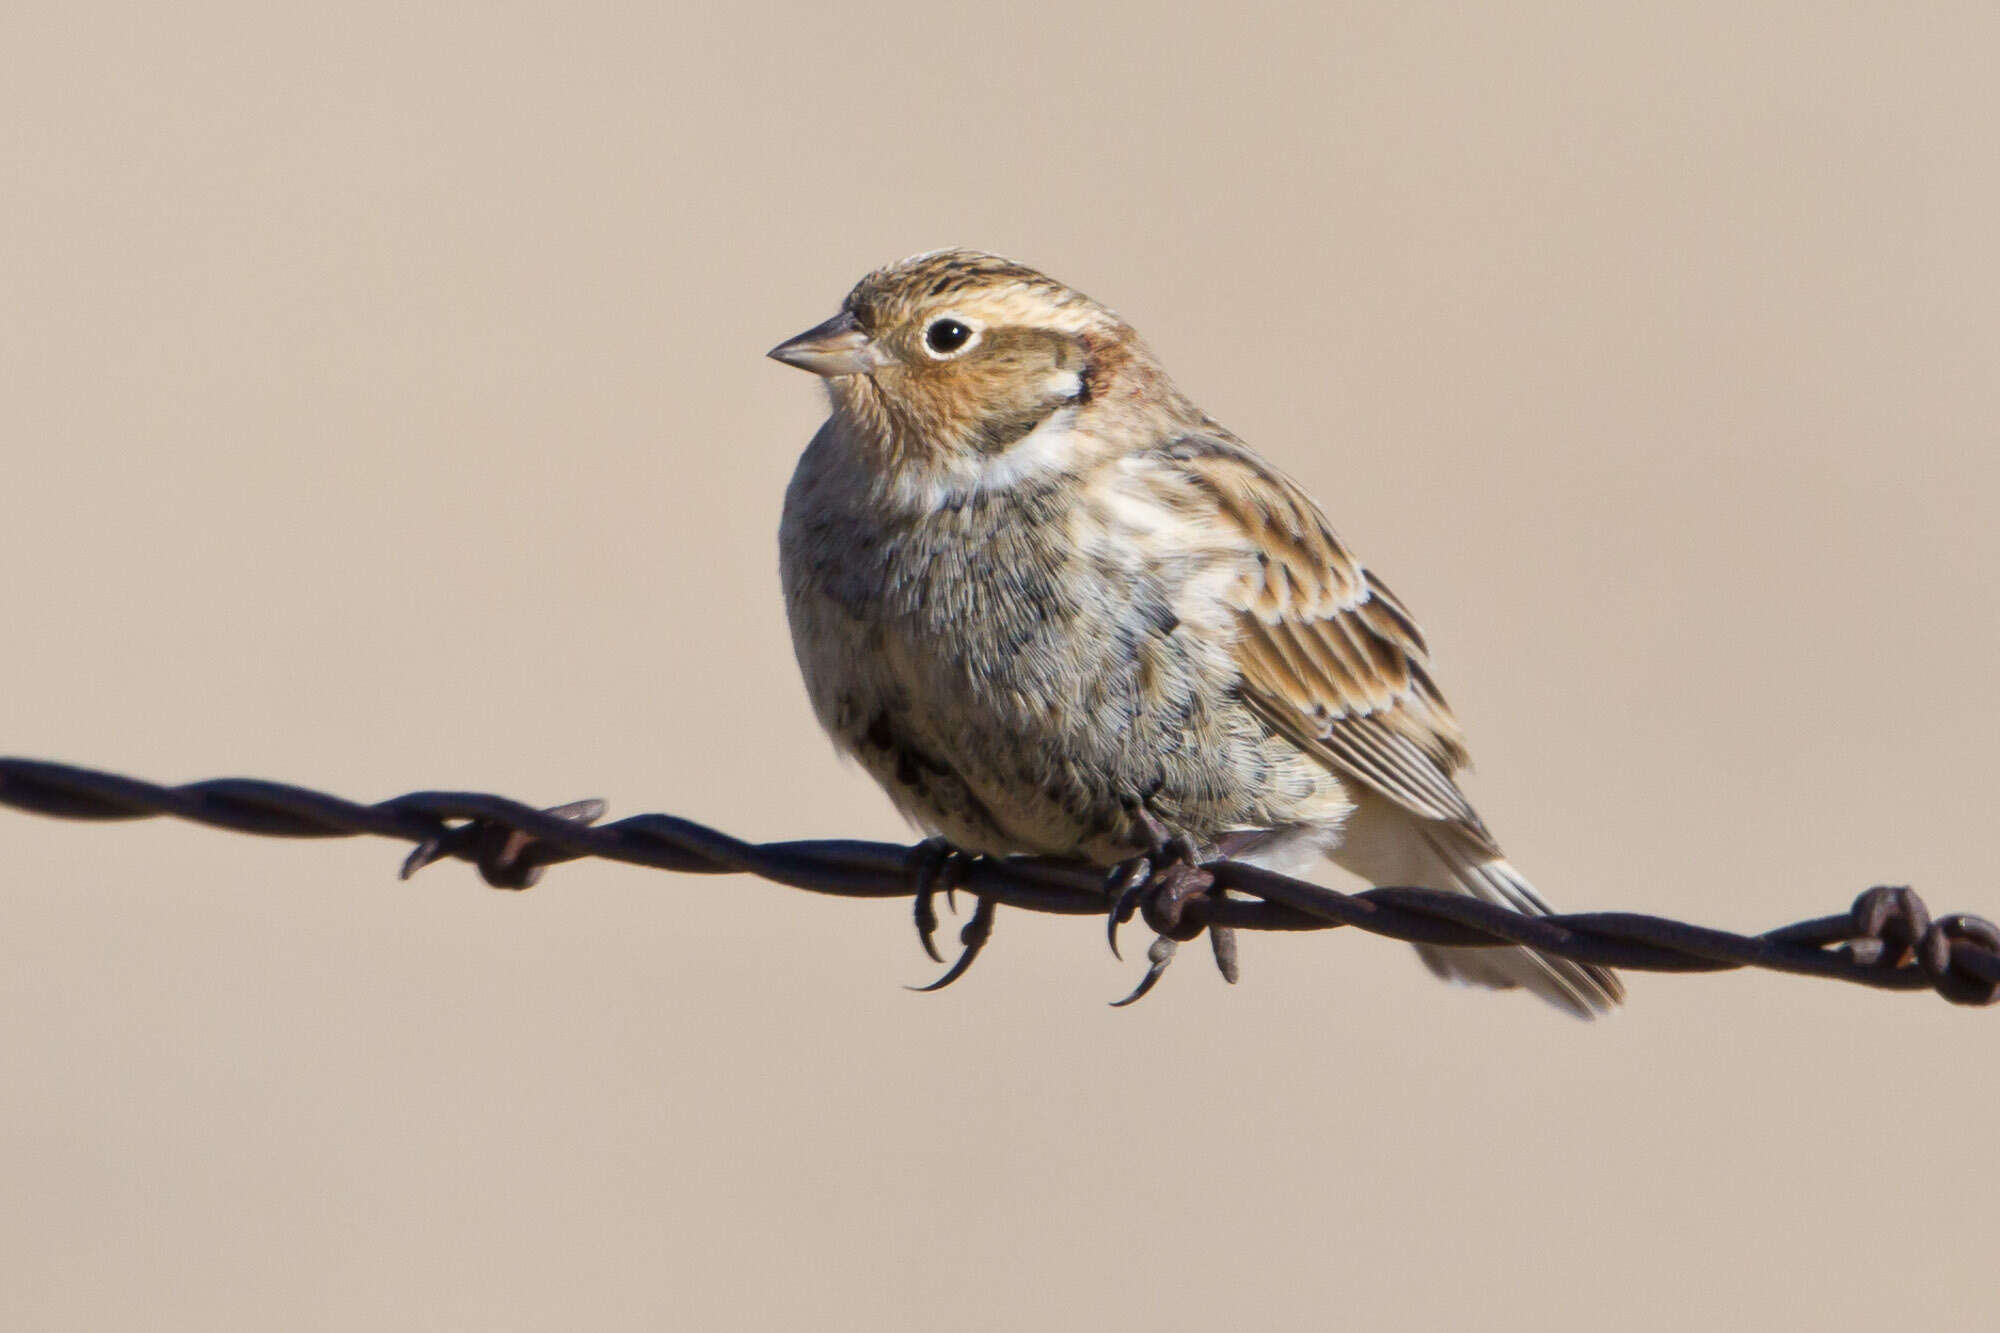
[0, 757, 2000, 1005]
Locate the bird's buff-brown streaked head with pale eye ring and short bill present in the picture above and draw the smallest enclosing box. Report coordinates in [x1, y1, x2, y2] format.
[770, 250, 1150, 482]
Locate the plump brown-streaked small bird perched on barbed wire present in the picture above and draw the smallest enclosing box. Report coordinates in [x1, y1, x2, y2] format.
[770, 248, 1624, 1019]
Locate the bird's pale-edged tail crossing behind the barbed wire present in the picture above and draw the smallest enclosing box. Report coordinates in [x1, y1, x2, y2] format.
[1330, 797, 1624, 1019]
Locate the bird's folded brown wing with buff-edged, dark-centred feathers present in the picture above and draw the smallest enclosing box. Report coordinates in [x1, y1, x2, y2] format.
[1162, 434, 1498, 855]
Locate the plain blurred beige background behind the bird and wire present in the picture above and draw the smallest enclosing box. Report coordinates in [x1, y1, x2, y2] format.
[0, 2, 2000, 1329]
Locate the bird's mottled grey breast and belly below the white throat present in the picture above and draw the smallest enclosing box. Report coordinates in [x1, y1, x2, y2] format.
[780, 454, 1348, 861]
